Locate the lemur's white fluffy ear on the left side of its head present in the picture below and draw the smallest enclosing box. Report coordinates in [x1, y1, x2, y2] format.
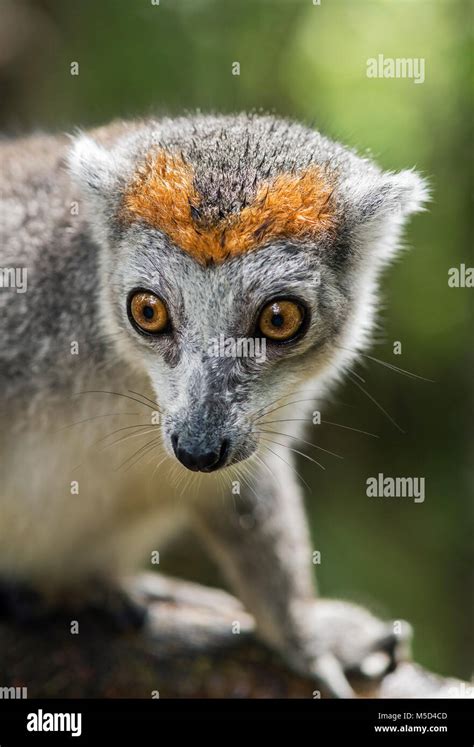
[67, 135, 129, 198]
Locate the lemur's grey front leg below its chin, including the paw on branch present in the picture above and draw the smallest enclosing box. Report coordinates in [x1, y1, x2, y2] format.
[194, 464, 410, 697]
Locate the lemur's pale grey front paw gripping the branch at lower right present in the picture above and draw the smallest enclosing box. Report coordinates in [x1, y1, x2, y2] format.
[290, 600, 412, 698]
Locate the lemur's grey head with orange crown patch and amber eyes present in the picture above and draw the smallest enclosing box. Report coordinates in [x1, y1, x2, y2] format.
[70, 115, 427, 471]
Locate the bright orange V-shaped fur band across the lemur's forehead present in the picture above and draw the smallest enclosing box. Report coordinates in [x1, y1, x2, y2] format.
[120, 149, 335, 264]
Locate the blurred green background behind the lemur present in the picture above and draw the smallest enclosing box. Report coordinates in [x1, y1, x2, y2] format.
[0, 0, 474, 677]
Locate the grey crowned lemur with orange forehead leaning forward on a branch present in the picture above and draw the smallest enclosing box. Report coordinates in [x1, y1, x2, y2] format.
[0, 114, 427, 696]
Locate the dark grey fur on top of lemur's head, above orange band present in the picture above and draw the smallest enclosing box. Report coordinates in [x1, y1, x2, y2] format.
[126, 114, 376, 231]
